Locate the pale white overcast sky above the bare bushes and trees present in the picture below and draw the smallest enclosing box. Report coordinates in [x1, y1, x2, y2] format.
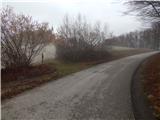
[2, 0, 146, 35]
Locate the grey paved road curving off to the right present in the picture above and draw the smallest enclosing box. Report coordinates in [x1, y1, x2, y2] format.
[2, 53, 158, 120]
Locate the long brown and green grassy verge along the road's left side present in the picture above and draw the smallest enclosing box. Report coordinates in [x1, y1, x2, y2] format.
[1, 49, 149, 100]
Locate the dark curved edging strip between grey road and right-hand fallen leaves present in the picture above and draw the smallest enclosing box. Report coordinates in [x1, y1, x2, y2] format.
[131, 53, 157, 120]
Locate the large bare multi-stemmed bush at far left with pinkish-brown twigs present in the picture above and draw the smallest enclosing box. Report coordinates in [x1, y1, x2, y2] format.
[1, 7, 52, 68]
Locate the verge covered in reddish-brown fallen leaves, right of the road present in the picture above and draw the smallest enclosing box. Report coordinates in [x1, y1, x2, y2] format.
[142, 54, 160, 120]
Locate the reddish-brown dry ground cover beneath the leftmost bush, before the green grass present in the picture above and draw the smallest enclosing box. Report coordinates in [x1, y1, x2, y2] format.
[1, 65, 58, 100]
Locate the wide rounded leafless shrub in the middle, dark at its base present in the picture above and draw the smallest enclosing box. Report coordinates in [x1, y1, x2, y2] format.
[56, 15, 107, 61]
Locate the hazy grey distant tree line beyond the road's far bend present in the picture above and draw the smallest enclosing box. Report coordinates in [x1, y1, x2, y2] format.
[105, 23, 160, 50]
